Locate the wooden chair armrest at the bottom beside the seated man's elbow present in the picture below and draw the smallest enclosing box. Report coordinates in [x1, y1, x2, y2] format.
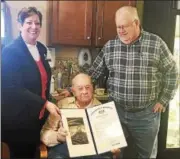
[36, 143, 48, 159]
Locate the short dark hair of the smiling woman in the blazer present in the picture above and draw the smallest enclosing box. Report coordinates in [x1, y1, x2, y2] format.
[18, 7, 42, 25]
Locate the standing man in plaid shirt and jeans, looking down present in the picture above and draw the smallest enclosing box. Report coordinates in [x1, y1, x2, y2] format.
[86, 6, 177, 158]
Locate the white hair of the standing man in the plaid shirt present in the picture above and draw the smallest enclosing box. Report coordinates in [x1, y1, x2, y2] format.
[115, 6, 139, 21]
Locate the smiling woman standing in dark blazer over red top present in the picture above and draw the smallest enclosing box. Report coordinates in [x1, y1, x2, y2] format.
[1, 7, 60, 158]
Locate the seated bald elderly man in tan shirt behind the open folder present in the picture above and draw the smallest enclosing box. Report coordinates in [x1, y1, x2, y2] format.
[41, 73, 120, 159]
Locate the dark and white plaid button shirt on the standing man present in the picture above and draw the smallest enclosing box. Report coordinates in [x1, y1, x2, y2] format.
[89, 30, 178, 110]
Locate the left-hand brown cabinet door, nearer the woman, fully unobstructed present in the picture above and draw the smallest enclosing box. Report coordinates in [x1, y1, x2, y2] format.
[50, 0, 93, 46]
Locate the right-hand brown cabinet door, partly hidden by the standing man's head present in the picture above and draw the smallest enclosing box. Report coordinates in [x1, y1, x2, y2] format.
[95, 0, 136, 47]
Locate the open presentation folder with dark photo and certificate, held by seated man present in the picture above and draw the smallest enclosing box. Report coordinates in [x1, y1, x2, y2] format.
[61, 102, 127, 157]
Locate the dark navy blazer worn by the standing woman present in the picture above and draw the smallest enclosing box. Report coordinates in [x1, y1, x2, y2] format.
[1, 36, 51, 142]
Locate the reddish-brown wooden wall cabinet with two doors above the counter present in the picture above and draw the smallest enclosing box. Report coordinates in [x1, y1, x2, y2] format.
[49, 0, 136, 47]
